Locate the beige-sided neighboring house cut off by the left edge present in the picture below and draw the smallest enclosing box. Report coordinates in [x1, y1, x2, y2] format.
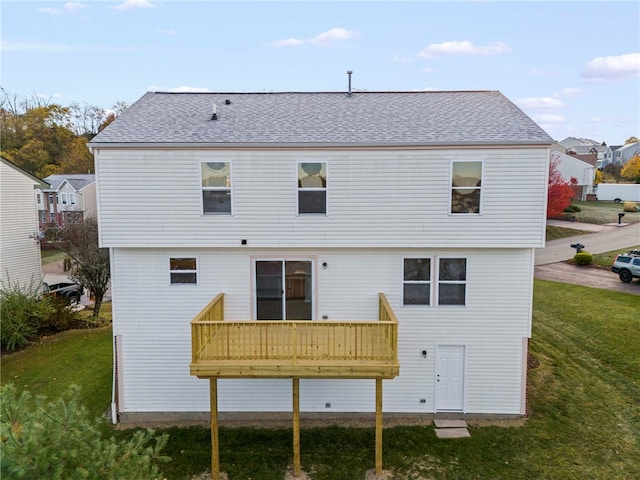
[0, 157, 48, 290]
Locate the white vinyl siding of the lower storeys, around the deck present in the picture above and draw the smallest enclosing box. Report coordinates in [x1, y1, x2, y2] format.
[112, 247, 534, 414]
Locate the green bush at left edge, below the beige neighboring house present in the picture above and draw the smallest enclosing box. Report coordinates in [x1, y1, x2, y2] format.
[0, 281, 53, 351]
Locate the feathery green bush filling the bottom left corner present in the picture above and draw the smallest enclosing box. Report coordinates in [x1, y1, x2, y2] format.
[0, 384, 170, 480]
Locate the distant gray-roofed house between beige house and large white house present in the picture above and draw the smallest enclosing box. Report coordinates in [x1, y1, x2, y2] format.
[36, 174, 96, 231]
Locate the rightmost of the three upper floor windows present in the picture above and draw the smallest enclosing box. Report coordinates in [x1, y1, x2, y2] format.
[451, 161, 482, 213]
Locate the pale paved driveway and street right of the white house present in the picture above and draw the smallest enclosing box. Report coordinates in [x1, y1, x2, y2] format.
[535, 220, 640, 295]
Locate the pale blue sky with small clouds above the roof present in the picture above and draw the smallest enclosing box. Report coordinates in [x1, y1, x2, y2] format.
[0, 0, 640, 145]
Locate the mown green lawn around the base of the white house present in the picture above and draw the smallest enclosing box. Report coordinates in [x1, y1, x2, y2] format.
[3, 280, 640, 480]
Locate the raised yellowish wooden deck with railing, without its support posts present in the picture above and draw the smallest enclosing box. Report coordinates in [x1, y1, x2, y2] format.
[190, 293, 399, 378]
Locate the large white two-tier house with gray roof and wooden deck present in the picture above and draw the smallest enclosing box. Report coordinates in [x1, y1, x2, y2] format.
[90, 91, 552, 421]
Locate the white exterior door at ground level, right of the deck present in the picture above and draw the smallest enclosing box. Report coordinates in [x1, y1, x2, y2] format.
[436, 345, 464, 412]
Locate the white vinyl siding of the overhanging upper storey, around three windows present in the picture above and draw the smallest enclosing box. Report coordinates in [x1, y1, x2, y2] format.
[96, 147, 548, 248]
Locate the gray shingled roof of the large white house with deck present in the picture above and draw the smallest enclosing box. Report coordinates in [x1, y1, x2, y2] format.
[91, 91, 553, 146]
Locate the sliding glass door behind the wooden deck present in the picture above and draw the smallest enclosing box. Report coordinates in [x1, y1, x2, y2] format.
[255, 260, 313, 320]
